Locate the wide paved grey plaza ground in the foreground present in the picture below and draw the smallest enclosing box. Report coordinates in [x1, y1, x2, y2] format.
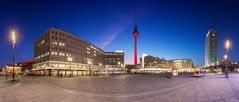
[0, 73, 239, 102]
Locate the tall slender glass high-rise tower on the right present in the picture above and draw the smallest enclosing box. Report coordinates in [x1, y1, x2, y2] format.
[205, 28, 217, 66]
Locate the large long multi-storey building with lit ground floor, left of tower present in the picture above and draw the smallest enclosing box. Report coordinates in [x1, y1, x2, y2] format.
[33, 28, 124, 75]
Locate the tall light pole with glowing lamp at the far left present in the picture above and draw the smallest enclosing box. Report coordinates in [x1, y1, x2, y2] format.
[11, 31, 16, 81]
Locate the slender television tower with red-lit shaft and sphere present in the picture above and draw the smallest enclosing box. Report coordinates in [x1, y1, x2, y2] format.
[133, 17, 139, 65]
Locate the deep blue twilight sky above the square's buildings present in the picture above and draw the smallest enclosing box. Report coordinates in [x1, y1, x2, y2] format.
[0, 0, 239, 67]
